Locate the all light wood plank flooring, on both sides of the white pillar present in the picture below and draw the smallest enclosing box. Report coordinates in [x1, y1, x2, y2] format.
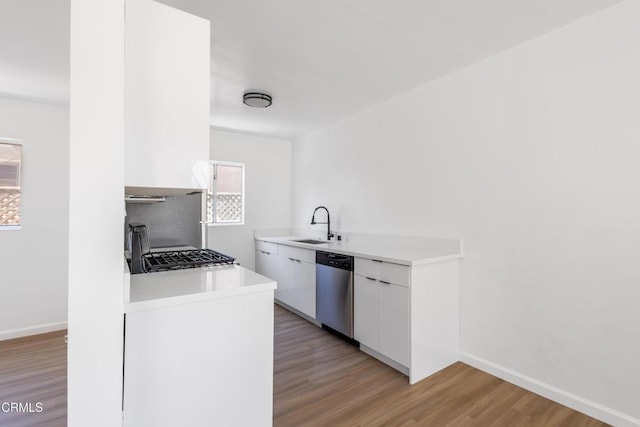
[0, 306, 606, 427]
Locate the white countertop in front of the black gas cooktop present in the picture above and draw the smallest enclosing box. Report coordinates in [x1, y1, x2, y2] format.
[125, 265, 276, 313]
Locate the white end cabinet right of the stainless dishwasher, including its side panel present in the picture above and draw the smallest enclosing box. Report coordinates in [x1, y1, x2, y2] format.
[354, 257, 458, 384]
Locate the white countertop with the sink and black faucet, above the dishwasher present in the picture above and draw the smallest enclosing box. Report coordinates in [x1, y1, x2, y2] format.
[255, 235, 462, 266]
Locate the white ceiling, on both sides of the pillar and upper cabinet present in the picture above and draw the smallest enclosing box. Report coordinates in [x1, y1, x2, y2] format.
[0, 0, 621, 139]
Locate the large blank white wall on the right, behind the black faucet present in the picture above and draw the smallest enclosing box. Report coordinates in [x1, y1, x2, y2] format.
[292, 1, 640, 425]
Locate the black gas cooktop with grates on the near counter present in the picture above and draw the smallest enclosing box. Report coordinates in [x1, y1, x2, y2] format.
[143, 249, 235, 273]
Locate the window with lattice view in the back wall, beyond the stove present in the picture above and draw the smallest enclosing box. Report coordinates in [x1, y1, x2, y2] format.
[207, 161, 244, 225]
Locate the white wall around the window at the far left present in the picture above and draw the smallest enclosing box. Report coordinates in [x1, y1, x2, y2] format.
[0, 98, 69, 340]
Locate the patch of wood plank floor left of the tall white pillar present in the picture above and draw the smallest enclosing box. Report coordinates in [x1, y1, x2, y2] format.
[0, 331, 67, 427]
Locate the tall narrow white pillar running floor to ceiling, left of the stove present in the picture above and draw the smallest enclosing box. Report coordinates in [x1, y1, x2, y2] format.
[67, 0, 125, 427]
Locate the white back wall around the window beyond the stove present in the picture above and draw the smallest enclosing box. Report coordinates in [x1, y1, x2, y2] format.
[208, 129, 291, 270]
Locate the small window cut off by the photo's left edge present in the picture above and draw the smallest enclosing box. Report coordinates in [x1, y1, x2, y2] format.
[0, 139, 22, 229]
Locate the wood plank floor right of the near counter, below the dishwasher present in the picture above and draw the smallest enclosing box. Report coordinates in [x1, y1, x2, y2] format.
[274, 305, 607, 427]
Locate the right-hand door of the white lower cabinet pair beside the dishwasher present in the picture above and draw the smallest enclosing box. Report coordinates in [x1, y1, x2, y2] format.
[378, 282, 409, 367]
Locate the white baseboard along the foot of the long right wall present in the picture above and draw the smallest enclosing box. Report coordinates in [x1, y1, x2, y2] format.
[460, 352, 640, 427]
